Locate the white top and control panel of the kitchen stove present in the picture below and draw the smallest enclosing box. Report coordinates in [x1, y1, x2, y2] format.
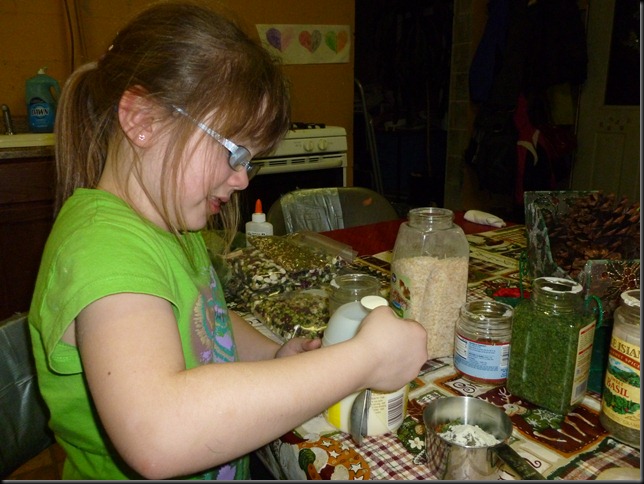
[253, 123, 347, 177]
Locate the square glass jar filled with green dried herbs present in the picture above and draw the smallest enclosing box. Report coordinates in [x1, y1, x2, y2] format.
[507, 277, 595, 415]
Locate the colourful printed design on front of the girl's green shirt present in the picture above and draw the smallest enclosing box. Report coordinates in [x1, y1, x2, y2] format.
[193, 267, 235, 364]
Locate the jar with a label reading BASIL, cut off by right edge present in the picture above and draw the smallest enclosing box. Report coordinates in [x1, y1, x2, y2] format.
[599, 289, 640, 449]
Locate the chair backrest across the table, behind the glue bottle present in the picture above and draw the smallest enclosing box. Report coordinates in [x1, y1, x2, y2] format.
[266, 187, 400, 235]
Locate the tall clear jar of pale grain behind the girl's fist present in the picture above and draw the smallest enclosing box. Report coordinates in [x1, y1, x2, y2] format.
[389, 207, 469, 359]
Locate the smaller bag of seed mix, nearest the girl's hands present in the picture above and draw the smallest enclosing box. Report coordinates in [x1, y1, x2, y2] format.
[251, 289, 329, 341]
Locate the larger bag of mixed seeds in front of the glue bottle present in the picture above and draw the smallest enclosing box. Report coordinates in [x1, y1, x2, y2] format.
[225, 236, 347, 311]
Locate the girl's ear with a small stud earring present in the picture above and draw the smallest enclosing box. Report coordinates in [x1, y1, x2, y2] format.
[118, 89, 155, 148]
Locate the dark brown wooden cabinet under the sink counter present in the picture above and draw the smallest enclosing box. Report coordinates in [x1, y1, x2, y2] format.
[0, 156, 55, 319]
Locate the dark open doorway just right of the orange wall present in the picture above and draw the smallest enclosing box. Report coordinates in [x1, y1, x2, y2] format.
[354, 0, 454, 213]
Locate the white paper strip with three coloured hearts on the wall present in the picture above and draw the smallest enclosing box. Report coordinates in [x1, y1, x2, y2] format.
[256, 24, 351, 64]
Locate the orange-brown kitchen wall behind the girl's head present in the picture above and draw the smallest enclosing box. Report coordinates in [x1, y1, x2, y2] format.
[0, 0, 355, 182]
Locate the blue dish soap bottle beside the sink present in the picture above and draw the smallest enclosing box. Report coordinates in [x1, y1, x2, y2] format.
[25, 67, 60, 133]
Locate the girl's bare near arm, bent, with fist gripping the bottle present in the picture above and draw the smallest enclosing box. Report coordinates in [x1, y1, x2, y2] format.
[76, 293, 427, 479]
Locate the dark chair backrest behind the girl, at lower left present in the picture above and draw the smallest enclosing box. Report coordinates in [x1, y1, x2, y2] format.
[0, 313, 54, 478]
